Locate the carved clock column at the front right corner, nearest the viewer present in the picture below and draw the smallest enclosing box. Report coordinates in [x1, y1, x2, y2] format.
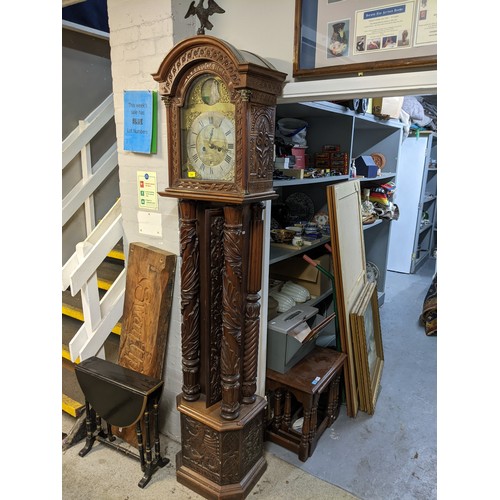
[221, 205, 243, 420]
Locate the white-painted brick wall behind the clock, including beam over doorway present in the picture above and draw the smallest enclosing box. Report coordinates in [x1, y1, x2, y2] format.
[108, 0, 436, 441]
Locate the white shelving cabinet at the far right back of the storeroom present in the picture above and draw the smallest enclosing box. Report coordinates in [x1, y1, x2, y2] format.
[387, 131, 437, 273]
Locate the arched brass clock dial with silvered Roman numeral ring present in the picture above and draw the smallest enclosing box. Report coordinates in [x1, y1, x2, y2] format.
[181, 75, 235, 182]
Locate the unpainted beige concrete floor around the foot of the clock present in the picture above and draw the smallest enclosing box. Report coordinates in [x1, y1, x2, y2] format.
[62, 413, 357, 500]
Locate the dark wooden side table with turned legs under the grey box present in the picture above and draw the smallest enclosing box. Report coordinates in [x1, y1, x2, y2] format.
[265, 347, 347, 462]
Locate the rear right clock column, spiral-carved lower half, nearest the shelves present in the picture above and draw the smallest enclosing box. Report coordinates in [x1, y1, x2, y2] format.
[242, 203, 264, 404]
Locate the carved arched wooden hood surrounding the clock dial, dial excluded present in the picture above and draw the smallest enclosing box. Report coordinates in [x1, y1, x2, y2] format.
[152, 35, 286, 203]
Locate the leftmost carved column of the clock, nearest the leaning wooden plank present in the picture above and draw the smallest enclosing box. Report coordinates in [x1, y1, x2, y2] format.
[179, 200, 200, 401]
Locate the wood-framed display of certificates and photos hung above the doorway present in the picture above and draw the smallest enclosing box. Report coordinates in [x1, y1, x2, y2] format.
[293, 0, 437, 77]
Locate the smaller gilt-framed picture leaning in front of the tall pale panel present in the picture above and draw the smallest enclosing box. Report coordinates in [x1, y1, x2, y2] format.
[350, 281, 384, 415]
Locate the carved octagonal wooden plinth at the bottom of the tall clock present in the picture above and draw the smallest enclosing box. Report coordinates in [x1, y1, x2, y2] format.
[176, 395, 267, 499]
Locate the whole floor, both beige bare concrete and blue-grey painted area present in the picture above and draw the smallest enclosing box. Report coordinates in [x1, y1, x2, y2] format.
[62, 260, 437, 500]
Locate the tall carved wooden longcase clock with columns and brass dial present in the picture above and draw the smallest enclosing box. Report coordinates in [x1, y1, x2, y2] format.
[153, 35, 286, 498]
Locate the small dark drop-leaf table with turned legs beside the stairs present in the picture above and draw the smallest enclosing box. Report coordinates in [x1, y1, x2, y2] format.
[75, 356, 170, 488]
